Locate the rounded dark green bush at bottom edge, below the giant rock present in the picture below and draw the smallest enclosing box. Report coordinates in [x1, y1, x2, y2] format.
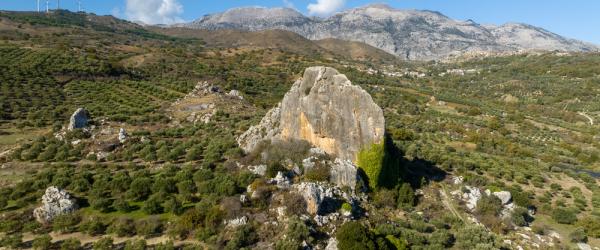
[336, 221, 377, 250]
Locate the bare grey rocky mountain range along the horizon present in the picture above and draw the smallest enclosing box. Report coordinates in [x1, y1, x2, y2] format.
[183, 4, 599, 60]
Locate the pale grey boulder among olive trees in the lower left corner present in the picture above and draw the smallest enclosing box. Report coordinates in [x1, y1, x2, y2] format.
[33, 187, 77, 223]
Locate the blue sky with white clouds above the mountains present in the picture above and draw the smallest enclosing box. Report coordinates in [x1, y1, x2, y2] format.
[0, 0, 600, 44]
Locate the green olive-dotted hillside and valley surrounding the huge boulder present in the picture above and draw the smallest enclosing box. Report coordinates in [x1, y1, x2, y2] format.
[0, 11, 600, 249]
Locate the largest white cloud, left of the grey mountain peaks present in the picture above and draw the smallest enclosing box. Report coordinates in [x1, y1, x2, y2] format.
[125, 0, 183, 24]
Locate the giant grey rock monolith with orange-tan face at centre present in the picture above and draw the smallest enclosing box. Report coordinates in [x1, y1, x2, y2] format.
[238, 67, 385, 161]
